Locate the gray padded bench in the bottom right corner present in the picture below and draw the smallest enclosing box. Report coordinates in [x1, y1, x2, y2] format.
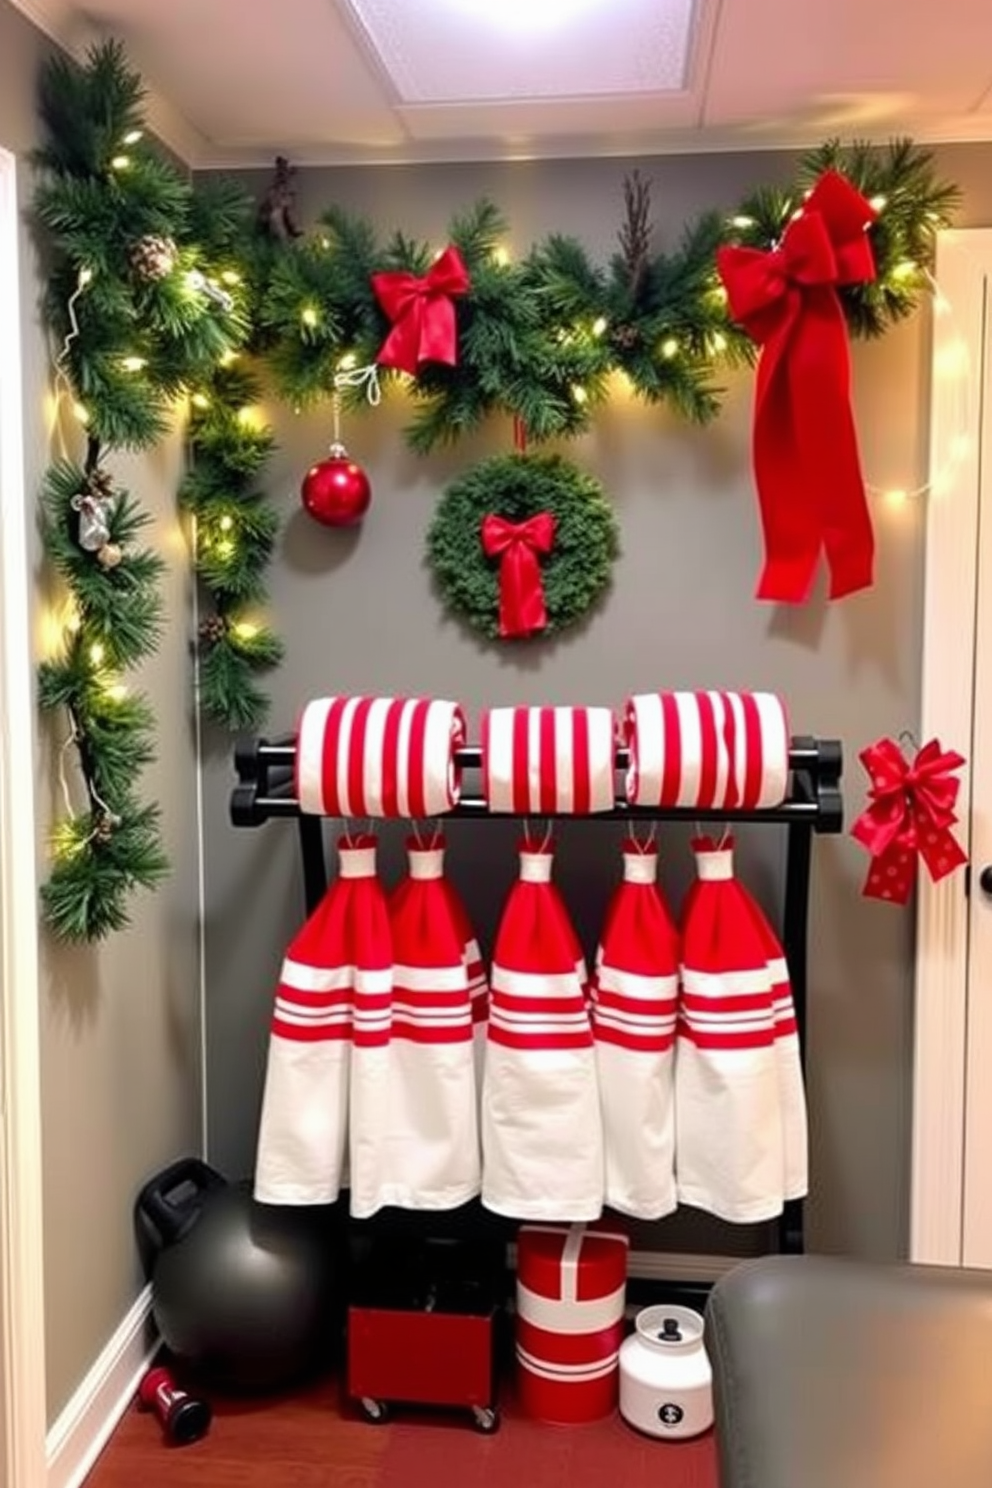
[706, 1256, 992, 1488]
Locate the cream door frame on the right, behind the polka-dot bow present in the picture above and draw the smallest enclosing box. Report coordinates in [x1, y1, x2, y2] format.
[910, 229, 992, 1266]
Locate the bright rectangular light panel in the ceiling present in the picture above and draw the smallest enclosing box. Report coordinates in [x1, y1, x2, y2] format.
[344, 0, 695, 106]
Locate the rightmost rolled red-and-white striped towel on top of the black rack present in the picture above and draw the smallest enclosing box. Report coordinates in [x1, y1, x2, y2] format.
[623, 692, 790, 809]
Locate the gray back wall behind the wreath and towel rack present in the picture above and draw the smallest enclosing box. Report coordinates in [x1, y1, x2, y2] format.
[205, 149, 992, 1256]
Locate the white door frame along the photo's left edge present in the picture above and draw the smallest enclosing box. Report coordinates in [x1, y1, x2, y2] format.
[0, 149, 46, 1488]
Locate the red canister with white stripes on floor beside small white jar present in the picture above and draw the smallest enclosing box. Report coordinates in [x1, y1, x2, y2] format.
[516, 1225, 628, 1426]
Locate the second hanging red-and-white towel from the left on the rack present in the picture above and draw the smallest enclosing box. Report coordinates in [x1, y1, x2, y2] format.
[351, 838, 480, 1219]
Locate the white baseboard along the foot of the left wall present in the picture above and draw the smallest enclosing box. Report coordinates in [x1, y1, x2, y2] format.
[46, 1286, 158, 1488]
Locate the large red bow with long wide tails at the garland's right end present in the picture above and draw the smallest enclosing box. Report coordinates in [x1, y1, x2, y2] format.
[717, 171, 876, 604]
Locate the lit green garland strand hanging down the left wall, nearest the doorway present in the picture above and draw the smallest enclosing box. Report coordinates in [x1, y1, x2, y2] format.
[34, 43, 255, 940]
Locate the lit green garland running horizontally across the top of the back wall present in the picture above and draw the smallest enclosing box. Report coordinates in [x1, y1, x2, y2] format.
[262, 141, 958, 454]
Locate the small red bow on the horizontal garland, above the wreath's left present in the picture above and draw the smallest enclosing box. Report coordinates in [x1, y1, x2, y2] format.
[372, 247, 471, 376]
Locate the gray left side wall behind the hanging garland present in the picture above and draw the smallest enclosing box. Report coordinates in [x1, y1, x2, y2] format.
[0, 0, 201, 1422]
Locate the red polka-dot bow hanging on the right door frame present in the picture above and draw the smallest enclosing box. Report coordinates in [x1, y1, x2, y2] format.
[851, 738, 968, 905]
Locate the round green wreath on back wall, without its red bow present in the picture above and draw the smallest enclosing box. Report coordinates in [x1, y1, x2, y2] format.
[427, 454, 619, 640]
